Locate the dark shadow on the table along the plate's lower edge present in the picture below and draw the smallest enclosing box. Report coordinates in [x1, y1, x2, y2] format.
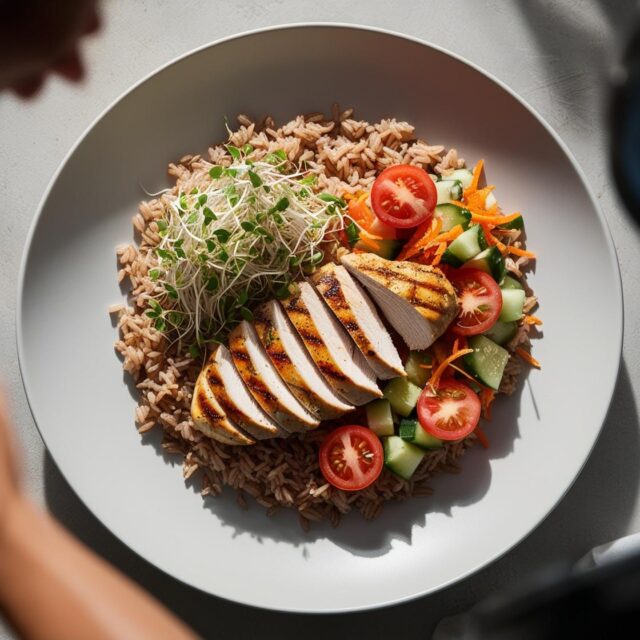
[45, 361, 640, 640]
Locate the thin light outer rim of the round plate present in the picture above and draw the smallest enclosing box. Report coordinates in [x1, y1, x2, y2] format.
[15, 21, 624, 614]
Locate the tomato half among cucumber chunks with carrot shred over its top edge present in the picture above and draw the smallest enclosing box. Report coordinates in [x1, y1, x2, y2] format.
[418, 378, 480, 440]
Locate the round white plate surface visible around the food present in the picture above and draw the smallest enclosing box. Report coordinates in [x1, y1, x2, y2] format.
[18, 25, 622, 611]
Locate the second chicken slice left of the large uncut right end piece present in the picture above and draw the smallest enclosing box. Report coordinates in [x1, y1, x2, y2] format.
[281, 282, 382, 405]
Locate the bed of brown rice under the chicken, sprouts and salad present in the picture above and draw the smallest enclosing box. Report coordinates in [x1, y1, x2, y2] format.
[114, 106, 536, 529]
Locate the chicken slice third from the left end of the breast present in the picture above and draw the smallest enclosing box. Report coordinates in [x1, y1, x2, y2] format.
[229, 320, 320, 431]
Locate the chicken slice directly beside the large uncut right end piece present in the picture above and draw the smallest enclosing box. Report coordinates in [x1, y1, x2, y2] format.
[311, 262, 406, 380]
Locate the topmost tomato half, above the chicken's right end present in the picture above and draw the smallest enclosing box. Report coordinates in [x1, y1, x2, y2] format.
[371, 164, 438, 229]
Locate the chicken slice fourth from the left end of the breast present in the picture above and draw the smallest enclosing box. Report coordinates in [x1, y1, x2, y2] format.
[253, 300, 354, 420]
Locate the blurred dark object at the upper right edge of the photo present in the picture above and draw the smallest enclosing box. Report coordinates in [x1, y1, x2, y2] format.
[610, 20, 640, 224]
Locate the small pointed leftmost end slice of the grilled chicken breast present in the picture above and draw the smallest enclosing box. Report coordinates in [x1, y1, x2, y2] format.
[191, 368, 256, 445]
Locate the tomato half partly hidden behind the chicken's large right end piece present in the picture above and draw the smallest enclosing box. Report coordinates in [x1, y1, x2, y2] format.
[449, 269, 502, 336]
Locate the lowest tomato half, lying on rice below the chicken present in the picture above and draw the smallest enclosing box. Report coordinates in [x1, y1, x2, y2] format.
[320, 425, 384, 491]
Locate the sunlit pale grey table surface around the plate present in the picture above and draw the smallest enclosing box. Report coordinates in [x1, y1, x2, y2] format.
[0, 0, 640, 640]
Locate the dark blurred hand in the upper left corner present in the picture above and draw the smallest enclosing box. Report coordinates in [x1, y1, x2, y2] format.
[0, 0, 100, 98]
